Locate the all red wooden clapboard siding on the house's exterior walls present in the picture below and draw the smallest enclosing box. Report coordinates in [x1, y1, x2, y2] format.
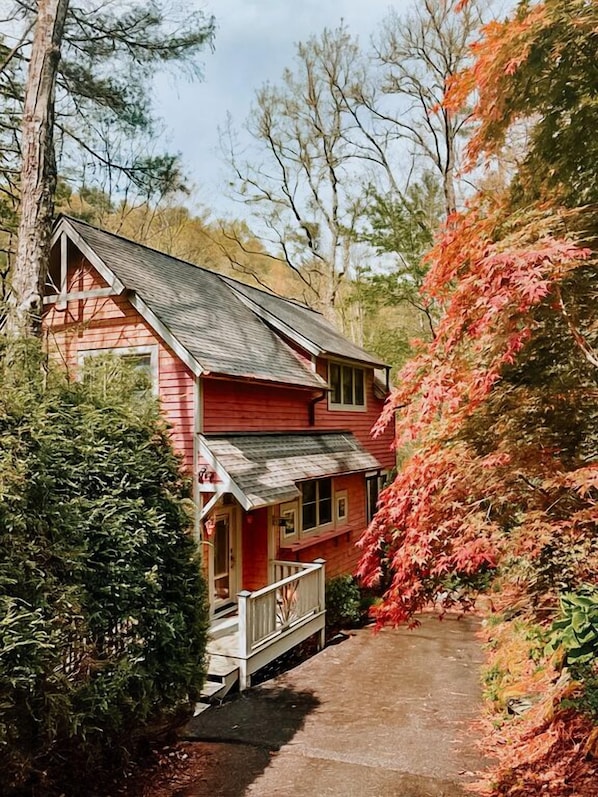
[44, 239, 394, 590]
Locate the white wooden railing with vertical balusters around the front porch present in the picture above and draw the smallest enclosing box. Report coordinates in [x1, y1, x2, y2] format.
[238, 559, 326, 689]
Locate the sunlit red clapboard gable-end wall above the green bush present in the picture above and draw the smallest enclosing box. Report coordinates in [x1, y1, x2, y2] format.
[44, 252, 195, 471]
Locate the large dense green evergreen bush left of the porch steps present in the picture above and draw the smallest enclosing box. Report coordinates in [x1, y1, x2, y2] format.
[0, 350, 208, 793]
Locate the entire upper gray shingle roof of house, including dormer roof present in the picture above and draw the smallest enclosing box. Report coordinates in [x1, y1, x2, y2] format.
[55, 216, 390, 388]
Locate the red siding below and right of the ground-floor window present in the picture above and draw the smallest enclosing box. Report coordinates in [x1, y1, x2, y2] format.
[276, 473, 366, 579]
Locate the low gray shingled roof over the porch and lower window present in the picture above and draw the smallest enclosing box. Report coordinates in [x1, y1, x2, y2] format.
[199, 432, 381, 509]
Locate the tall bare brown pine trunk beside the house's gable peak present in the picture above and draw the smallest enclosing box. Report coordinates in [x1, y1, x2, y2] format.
[7, 0, 69, 336]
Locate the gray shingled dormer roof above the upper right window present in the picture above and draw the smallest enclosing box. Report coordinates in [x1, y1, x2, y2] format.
[224, 277, 386, 367]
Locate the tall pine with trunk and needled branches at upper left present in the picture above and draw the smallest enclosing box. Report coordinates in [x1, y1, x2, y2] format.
[0, 0, 213, 335]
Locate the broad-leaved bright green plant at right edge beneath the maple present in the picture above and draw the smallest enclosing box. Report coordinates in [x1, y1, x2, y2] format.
[548, 584, 598, 664]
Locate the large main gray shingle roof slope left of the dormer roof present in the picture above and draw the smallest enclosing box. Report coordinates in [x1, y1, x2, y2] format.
[66, 218, 326, 387]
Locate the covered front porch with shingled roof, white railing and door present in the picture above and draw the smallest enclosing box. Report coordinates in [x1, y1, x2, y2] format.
[198, 432, 380, 697]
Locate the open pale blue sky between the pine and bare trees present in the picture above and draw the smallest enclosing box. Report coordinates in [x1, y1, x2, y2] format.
[155, 0, 400, 215]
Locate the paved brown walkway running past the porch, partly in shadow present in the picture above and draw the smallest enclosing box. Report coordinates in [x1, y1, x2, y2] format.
[181, 615, 483, 797]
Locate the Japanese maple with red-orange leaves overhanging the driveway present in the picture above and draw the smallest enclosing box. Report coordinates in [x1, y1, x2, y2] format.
[359, 0, 598, 624]
